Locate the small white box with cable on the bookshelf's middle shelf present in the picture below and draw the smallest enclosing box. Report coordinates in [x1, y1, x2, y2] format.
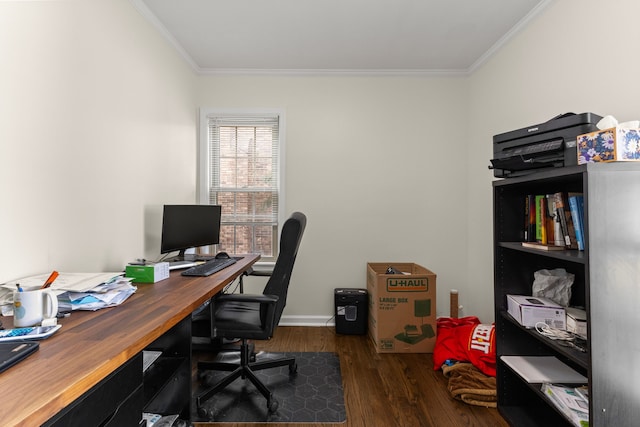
[507, 295, 566, 330]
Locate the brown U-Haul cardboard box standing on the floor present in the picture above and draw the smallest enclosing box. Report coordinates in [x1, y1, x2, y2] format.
[367, 262, 436, 353]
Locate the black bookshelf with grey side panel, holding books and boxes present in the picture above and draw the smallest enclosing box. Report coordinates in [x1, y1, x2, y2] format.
[493, 162, 640, 427]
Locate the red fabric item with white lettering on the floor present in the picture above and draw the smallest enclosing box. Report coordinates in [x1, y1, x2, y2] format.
[433, 316, 496, 377]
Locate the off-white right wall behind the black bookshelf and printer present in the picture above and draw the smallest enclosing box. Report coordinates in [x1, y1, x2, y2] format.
[467, 0, 640, 320]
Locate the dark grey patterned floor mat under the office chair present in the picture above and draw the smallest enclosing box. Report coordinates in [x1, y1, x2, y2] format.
[192, 352, 347, 423]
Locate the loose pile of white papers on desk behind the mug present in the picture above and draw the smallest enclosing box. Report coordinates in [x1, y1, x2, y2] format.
[0, 273, 137, 311]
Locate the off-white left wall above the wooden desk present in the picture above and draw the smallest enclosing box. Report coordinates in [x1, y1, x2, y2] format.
[0, 0, 196, 282]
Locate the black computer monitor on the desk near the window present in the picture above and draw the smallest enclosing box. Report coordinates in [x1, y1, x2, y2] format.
[160, 205, 222, 261]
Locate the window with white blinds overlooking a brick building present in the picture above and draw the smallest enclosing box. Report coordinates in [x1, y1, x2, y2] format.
[199, 110, 283, 262]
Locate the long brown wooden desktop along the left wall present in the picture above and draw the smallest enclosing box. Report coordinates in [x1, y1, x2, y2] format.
[0, 255, 260, 427]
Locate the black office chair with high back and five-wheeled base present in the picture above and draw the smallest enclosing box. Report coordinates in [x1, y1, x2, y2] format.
[196, 212, 307, 417]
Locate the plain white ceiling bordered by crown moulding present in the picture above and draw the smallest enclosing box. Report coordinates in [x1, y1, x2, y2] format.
[130, 0, 552, 74]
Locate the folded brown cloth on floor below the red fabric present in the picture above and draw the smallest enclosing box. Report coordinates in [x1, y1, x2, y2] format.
[442, 363, 498, 408]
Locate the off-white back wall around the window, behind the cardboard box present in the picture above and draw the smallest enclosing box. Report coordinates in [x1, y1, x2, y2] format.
[198, 76, 467, 320]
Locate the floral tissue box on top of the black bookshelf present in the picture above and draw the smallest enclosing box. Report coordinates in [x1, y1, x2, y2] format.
[577, 128, 640, 165]
